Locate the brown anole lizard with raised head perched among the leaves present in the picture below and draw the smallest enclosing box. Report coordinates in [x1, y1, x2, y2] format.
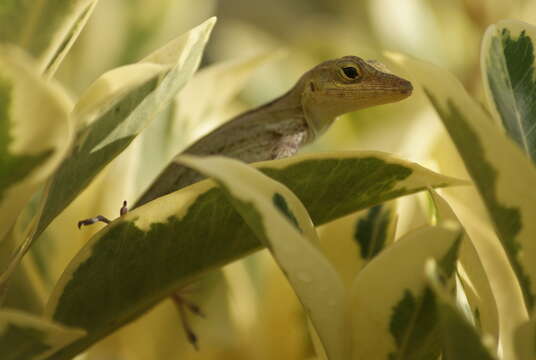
[134, 56, 413, 207]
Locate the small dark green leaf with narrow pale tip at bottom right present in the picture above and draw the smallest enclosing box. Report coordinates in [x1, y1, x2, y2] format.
[426, 260, 496, 360]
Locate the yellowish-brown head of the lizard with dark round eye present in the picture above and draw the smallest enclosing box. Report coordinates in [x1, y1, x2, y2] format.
[298, 56, 413, 135]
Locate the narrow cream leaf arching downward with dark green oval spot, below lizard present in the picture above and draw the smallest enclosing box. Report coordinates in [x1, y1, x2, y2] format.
[180, 155, 349, 360]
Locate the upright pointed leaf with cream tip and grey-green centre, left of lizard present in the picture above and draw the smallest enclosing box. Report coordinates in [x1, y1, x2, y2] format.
[35, 18, 215, 237]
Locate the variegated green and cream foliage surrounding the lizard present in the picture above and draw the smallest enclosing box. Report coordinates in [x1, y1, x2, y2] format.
[0, 0, 536, 360]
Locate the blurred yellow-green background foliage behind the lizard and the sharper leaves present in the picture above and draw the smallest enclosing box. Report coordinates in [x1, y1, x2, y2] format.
[12, 0, 536, 360]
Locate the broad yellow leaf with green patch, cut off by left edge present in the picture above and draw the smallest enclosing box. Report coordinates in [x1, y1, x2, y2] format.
[0, 46, 72, 243]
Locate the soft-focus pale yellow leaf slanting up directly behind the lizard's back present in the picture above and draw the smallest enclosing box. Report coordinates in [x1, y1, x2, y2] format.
[29, 53, 280, 298]
